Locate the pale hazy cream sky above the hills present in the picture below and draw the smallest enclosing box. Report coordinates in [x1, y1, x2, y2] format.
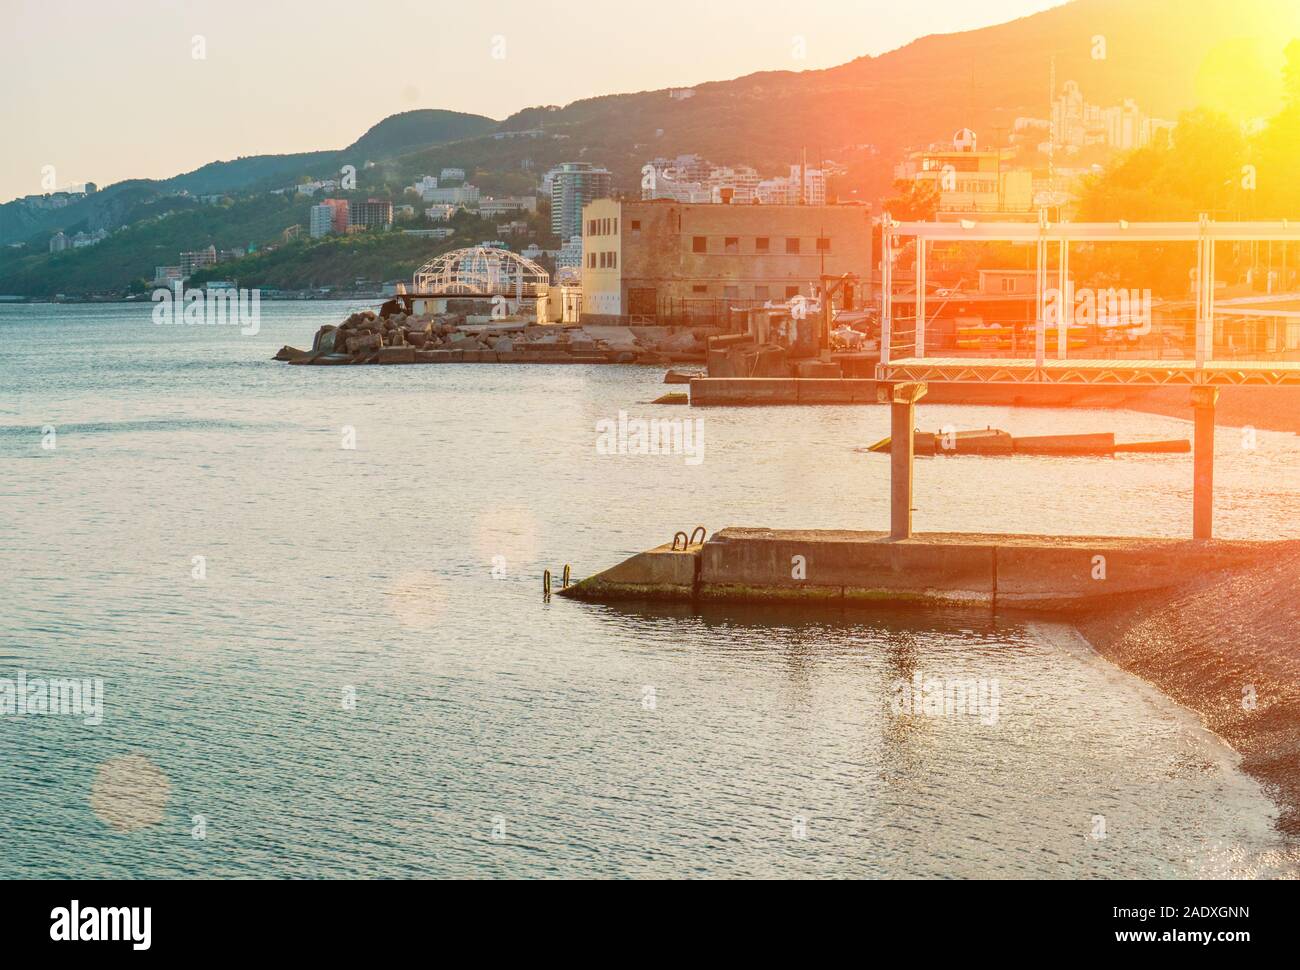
[0, 0, 1058, 202]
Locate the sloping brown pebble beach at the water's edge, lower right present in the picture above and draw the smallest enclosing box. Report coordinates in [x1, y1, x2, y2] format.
[1071, 553, 1300, 837]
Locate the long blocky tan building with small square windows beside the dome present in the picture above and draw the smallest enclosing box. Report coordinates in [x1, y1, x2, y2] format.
[582, 199, 872, 322]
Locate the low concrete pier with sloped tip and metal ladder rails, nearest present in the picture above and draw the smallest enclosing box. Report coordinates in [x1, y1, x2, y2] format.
[563, 528, 1300, 612]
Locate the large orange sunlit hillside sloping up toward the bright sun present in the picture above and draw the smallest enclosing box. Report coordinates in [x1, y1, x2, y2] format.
[488, 0, 1300, 200]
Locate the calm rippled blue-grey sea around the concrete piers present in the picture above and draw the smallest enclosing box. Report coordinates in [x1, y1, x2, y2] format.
[0, 303, 1300, 878]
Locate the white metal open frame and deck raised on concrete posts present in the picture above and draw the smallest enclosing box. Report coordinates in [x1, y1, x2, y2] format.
[878, 212, 1300, 385]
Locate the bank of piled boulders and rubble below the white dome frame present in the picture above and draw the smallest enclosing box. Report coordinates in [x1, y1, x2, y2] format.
[274, 304, 707, 365]
